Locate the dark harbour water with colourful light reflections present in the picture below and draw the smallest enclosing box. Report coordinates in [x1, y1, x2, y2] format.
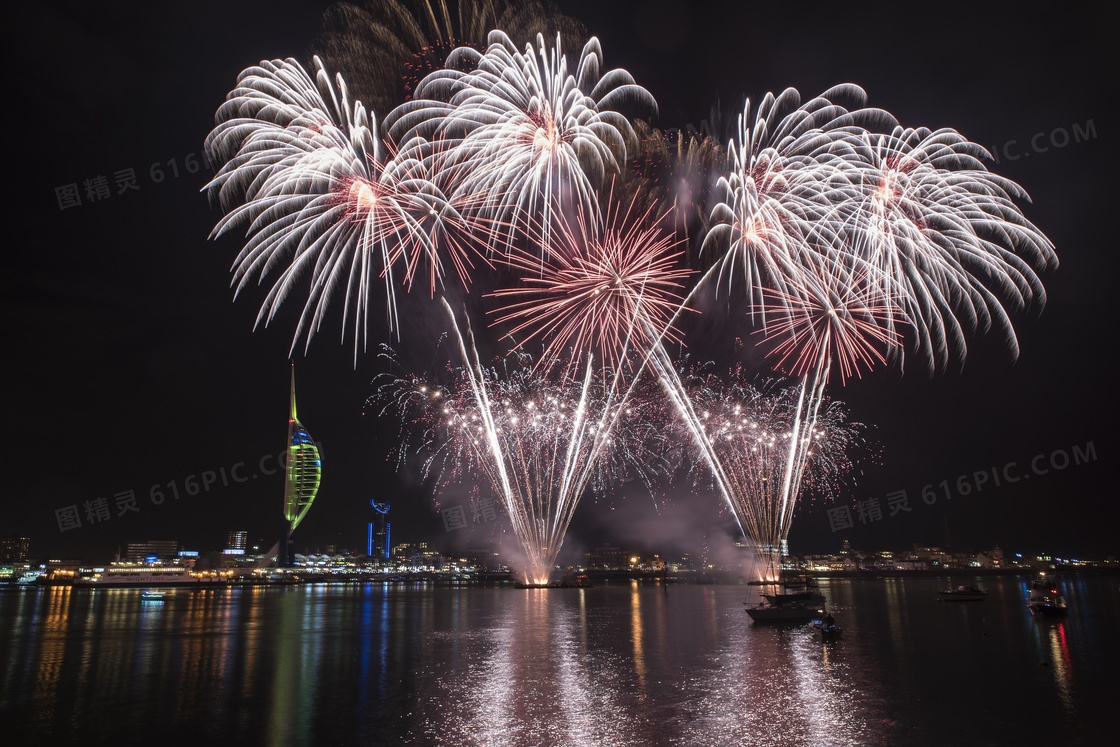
[0, 578, 1120, 747]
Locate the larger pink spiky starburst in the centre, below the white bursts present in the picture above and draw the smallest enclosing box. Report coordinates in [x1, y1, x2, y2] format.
[491, 192, 691, 367]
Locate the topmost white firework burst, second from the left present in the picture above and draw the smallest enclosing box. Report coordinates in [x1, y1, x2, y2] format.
[388, 30, 656, 251]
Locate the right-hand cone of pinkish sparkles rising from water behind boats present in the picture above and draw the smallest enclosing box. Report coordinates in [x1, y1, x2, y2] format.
[684, 370, 862, 579]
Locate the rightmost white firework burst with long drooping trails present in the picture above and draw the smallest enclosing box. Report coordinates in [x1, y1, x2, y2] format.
[838, 127, 1057, 373]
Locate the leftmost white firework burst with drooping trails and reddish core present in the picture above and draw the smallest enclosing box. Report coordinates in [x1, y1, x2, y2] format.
[205, 58, 489, 361]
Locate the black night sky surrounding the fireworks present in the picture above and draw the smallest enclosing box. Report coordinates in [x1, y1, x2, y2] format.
[0, 0, 1120, 558]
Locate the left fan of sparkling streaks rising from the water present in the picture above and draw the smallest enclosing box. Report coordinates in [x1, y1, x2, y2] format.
[381, 301, 668, 585]
